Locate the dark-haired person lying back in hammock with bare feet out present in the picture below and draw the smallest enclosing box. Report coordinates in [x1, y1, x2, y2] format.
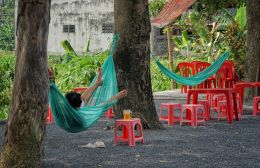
[48, 68, 128, 108]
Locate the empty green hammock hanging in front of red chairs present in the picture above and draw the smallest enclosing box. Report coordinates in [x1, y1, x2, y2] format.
[156, 52, 229, 86]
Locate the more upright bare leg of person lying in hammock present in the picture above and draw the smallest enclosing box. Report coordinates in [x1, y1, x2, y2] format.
[81, 67, 102, 104]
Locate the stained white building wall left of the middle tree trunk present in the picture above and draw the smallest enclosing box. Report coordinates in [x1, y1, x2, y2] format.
[48, 0, 114, 53]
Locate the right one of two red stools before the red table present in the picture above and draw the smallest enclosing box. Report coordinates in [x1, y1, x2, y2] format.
[180, 104, 205, 127]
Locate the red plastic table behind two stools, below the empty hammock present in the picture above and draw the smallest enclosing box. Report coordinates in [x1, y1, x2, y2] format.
[187, 88, 238, 123]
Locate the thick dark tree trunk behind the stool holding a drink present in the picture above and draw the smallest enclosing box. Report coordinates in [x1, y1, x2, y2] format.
[114, 0, 161, 128]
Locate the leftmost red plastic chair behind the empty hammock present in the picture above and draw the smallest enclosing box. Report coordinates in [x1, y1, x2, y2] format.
[177, 62, 195, 93]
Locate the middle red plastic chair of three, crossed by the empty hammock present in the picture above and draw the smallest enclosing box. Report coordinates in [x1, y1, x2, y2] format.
[195, 62, 216, 88]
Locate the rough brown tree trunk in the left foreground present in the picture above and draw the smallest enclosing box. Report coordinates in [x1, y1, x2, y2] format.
[0, 0, 50, 168]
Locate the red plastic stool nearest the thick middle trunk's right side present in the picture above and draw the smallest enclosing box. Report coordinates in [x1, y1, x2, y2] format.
[159, 103, 181, 125]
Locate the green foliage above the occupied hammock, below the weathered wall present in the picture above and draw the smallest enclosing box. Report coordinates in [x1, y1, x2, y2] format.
[49, 52, 108, 92]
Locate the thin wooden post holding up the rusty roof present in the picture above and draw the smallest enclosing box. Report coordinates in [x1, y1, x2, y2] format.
[167, 25, 176, 89]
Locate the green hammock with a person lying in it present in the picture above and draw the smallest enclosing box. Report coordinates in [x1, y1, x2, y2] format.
[49, 36, 118, 133]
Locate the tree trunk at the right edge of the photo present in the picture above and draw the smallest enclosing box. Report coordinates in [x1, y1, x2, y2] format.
[245, 0, 260, 95]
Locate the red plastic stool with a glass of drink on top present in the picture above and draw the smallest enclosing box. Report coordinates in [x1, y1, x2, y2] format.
[114, 118, 144, 146]
